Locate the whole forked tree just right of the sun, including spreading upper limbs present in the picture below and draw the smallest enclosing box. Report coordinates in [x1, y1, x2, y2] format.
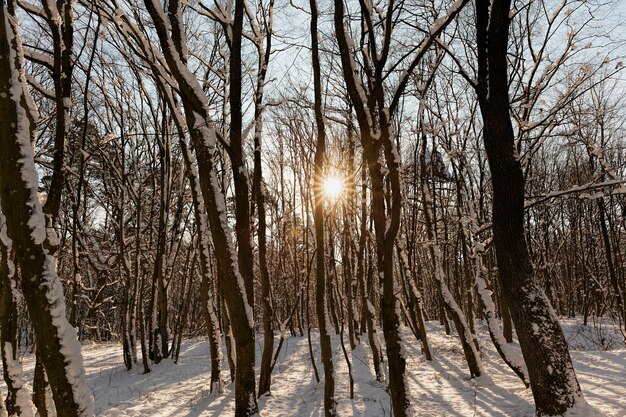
[334, 0, 467, 417]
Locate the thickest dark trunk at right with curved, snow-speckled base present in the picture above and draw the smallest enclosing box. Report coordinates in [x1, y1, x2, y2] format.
[476, 0, 588, 416]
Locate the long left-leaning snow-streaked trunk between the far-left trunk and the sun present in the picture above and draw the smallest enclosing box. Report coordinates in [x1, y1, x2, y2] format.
[140, 0, 258, 410]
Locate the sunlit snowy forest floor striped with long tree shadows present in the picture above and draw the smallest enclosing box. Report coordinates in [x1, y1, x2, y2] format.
[9, 321, 626, 417]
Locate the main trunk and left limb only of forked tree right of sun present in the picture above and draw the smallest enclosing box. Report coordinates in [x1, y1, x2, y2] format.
[334, 4, 411, 417]
